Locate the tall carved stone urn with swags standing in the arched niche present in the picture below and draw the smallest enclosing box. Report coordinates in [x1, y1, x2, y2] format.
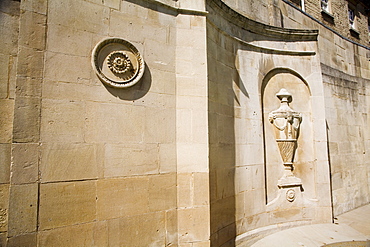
[269, 88, 302, 189]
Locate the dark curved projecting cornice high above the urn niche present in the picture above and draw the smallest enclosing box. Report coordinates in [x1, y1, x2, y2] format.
[208, 0, 319, 41]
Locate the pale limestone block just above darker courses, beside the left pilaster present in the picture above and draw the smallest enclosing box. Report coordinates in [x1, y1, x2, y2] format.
[40, 143, 104, 182]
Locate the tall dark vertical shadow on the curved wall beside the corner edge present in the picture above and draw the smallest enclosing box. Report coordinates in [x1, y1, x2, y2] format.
[207, 27, 249, 246]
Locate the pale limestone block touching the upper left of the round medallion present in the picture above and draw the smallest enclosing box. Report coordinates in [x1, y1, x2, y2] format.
[47, 25, 95, 56]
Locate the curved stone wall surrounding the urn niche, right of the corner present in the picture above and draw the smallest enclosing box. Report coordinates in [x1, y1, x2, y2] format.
[207, 0, 369, 246]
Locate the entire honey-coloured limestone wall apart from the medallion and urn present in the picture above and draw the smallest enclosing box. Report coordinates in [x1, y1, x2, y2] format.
[0, 0, 370, 247]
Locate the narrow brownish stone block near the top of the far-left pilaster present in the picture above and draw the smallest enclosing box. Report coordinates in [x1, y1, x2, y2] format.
[19, 11, 46, 50]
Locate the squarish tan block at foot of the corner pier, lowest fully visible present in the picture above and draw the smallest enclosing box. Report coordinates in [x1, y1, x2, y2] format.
[178, 206, 210, 243]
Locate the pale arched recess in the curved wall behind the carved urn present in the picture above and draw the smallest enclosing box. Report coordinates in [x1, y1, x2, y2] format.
[261, 68, 315, 204]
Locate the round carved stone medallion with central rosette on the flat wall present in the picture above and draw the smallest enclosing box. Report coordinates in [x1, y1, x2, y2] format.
[91, 38, 145, 88]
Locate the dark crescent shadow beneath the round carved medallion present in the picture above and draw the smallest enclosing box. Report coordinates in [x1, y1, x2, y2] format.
[103, 64, 152, 101]
